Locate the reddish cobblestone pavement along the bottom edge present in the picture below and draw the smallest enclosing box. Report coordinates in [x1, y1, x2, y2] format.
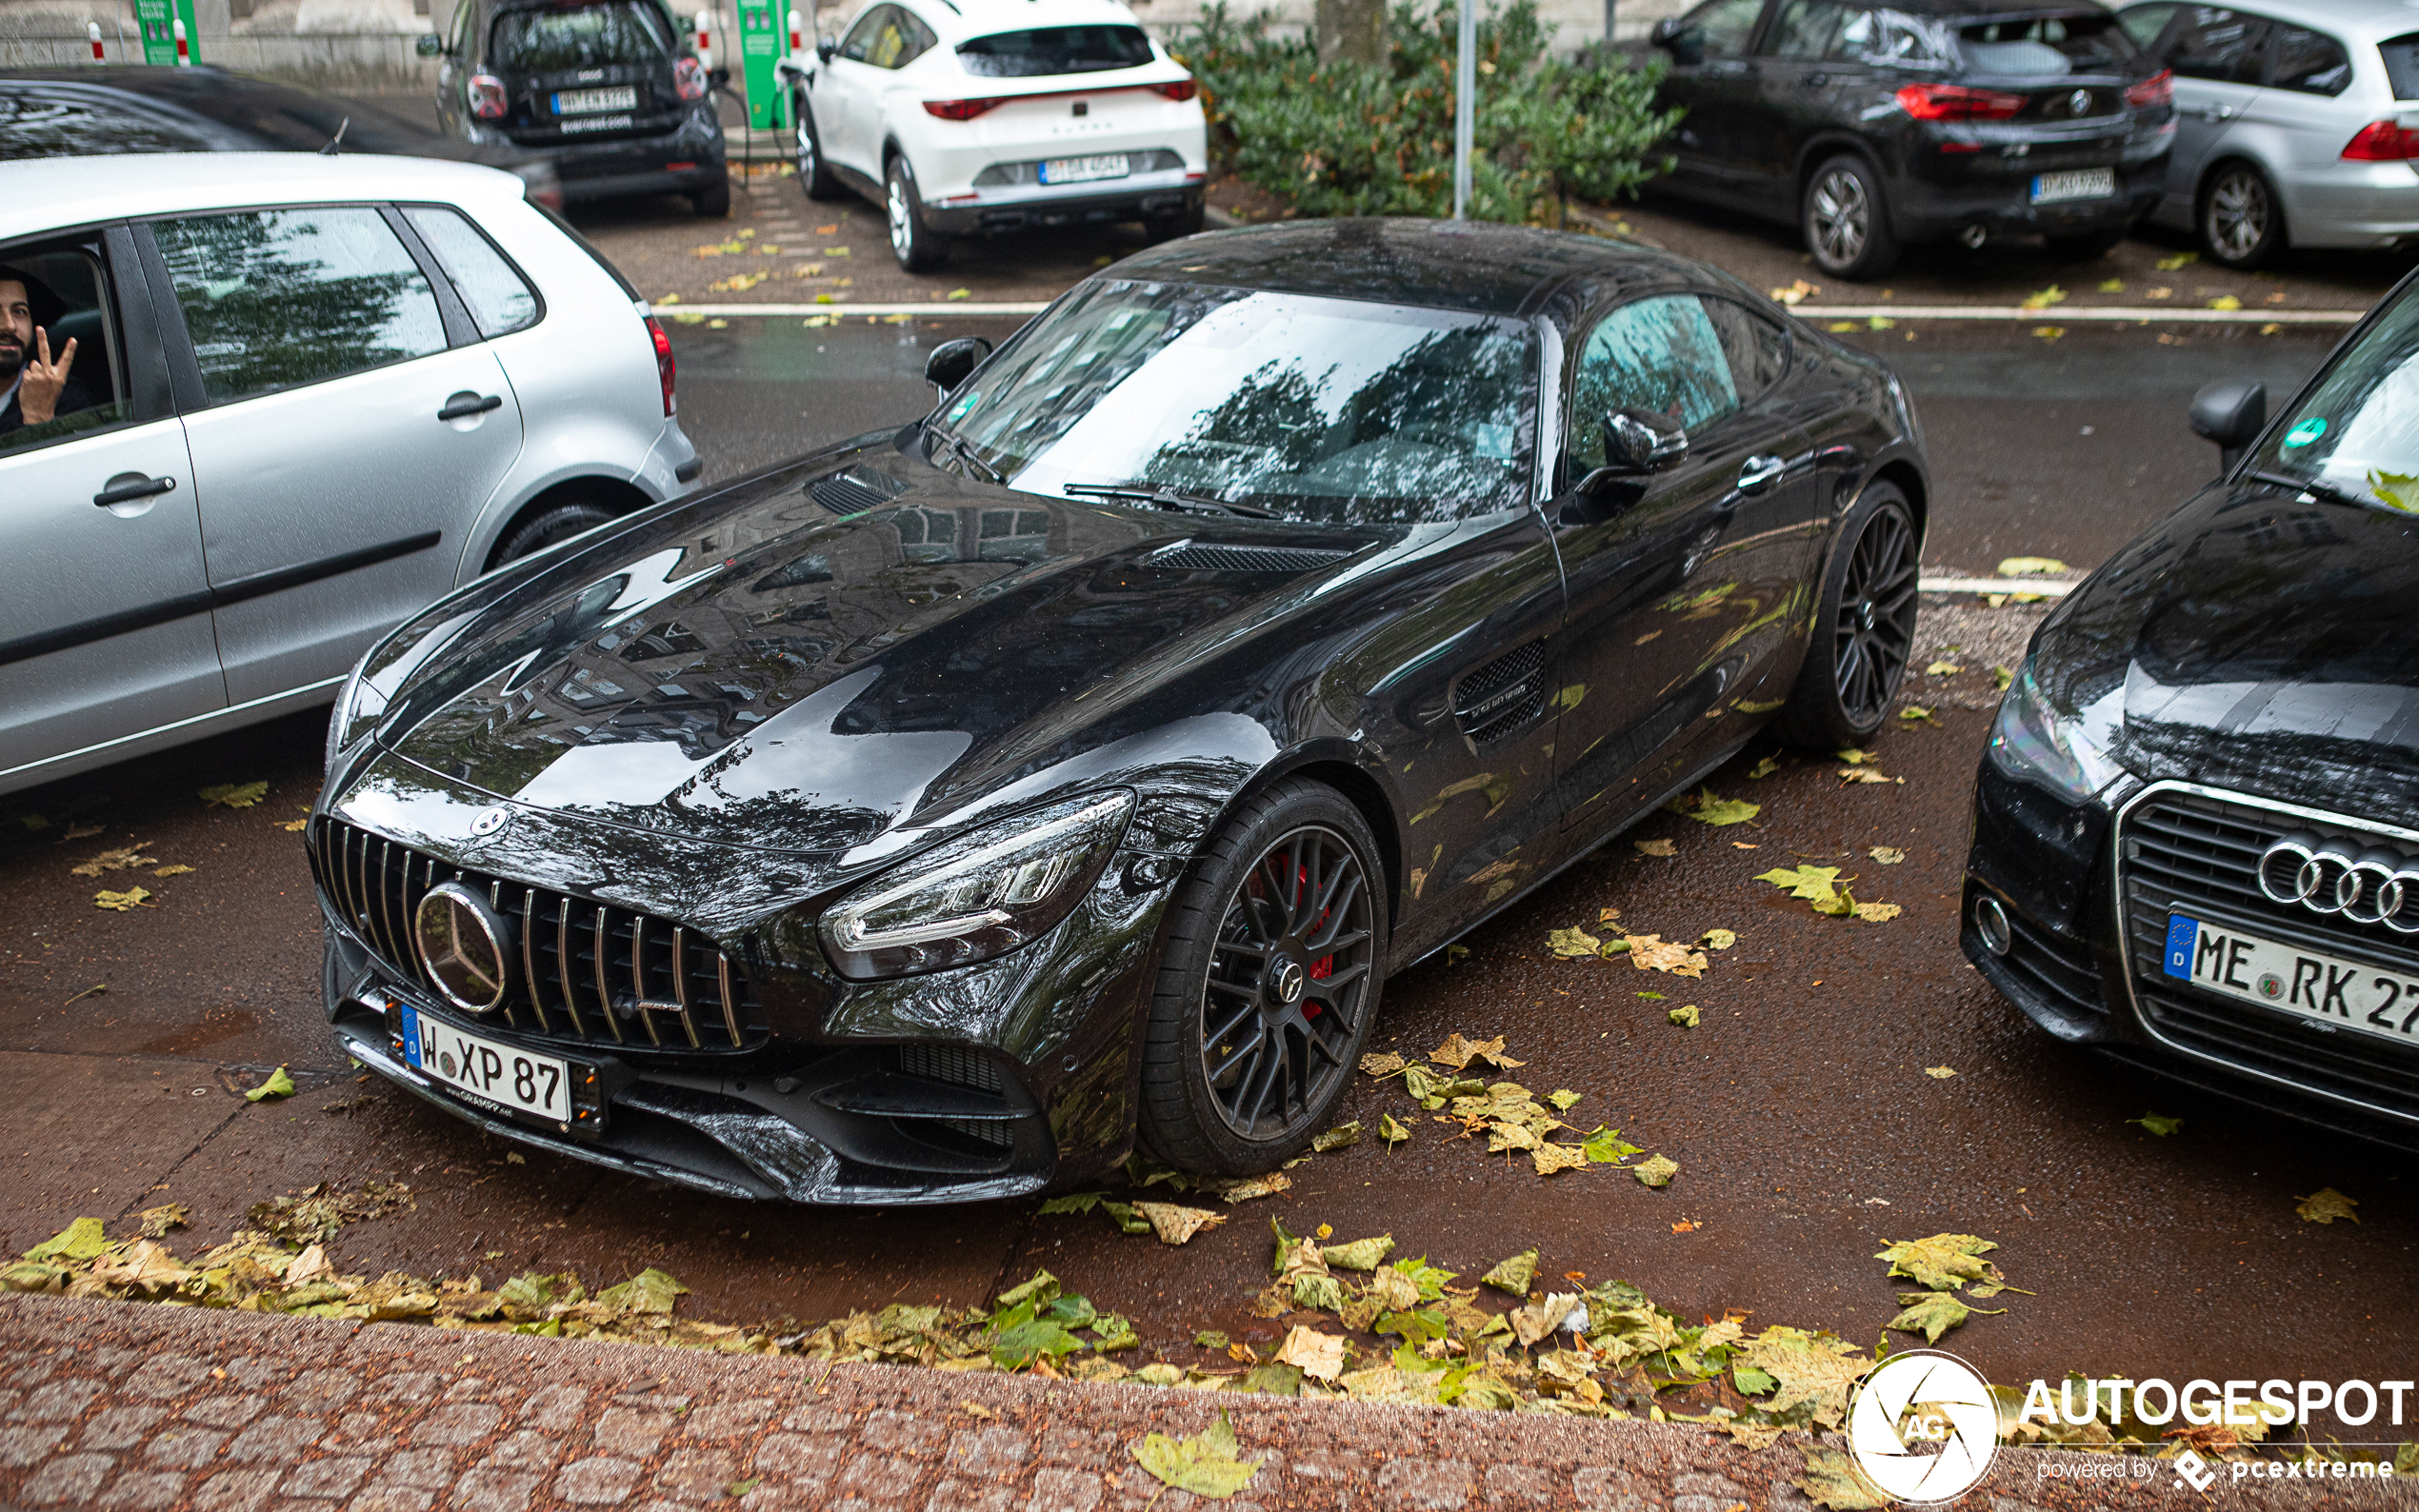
[0, 1297, 2407, 1512]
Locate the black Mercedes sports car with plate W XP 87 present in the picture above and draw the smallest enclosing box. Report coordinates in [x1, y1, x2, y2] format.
[310, 220, 1928, 1203]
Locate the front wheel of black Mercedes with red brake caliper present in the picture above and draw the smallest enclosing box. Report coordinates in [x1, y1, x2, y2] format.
[1139, 777, 1386, 1176]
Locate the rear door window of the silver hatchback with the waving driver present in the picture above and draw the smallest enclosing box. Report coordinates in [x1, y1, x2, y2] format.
[150, 206, 445, 404]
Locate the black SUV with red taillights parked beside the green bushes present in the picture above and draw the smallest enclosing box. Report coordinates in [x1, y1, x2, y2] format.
[1654, 0, 2174, 281]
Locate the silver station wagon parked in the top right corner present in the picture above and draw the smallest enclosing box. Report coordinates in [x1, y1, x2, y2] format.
[2119, 0, 2419, 269]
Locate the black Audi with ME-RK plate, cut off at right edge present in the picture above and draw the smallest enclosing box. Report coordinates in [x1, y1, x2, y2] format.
[1962, 278, 2419, 1144]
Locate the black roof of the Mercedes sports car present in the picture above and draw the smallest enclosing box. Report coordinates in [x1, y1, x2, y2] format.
[1112, 218, 1715, 314]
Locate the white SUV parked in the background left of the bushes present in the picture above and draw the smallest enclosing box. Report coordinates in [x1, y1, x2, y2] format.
[789, 0, 1210, 273]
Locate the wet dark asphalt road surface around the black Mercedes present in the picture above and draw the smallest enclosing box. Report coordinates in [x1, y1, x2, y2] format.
[0, 322, 2419, 1437]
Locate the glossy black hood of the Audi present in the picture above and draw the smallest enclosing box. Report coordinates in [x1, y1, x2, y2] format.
[2034, 484, 2419, 823]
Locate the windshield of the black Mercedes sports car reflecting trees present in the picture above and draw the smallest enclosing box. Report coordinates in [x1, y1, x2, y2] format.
[924, 278, 1536, 525]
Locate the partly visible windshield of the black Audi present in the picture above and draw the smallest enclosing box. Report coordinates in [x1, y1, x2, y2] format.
[2252, 290, 2419, 513]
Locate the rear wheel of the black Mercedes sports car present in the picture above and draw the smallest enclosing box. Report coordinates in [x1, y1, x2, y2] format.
[1778, 484, 1921, 750]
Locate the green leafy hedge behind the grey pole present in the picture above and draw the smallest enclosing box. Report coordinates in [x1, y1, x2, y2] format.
[1175, 0, 1679, 225]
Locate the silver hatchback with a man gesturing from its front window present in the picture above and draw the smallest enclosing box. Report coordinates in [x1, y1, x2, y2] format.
[0, 152, 702, 793]
